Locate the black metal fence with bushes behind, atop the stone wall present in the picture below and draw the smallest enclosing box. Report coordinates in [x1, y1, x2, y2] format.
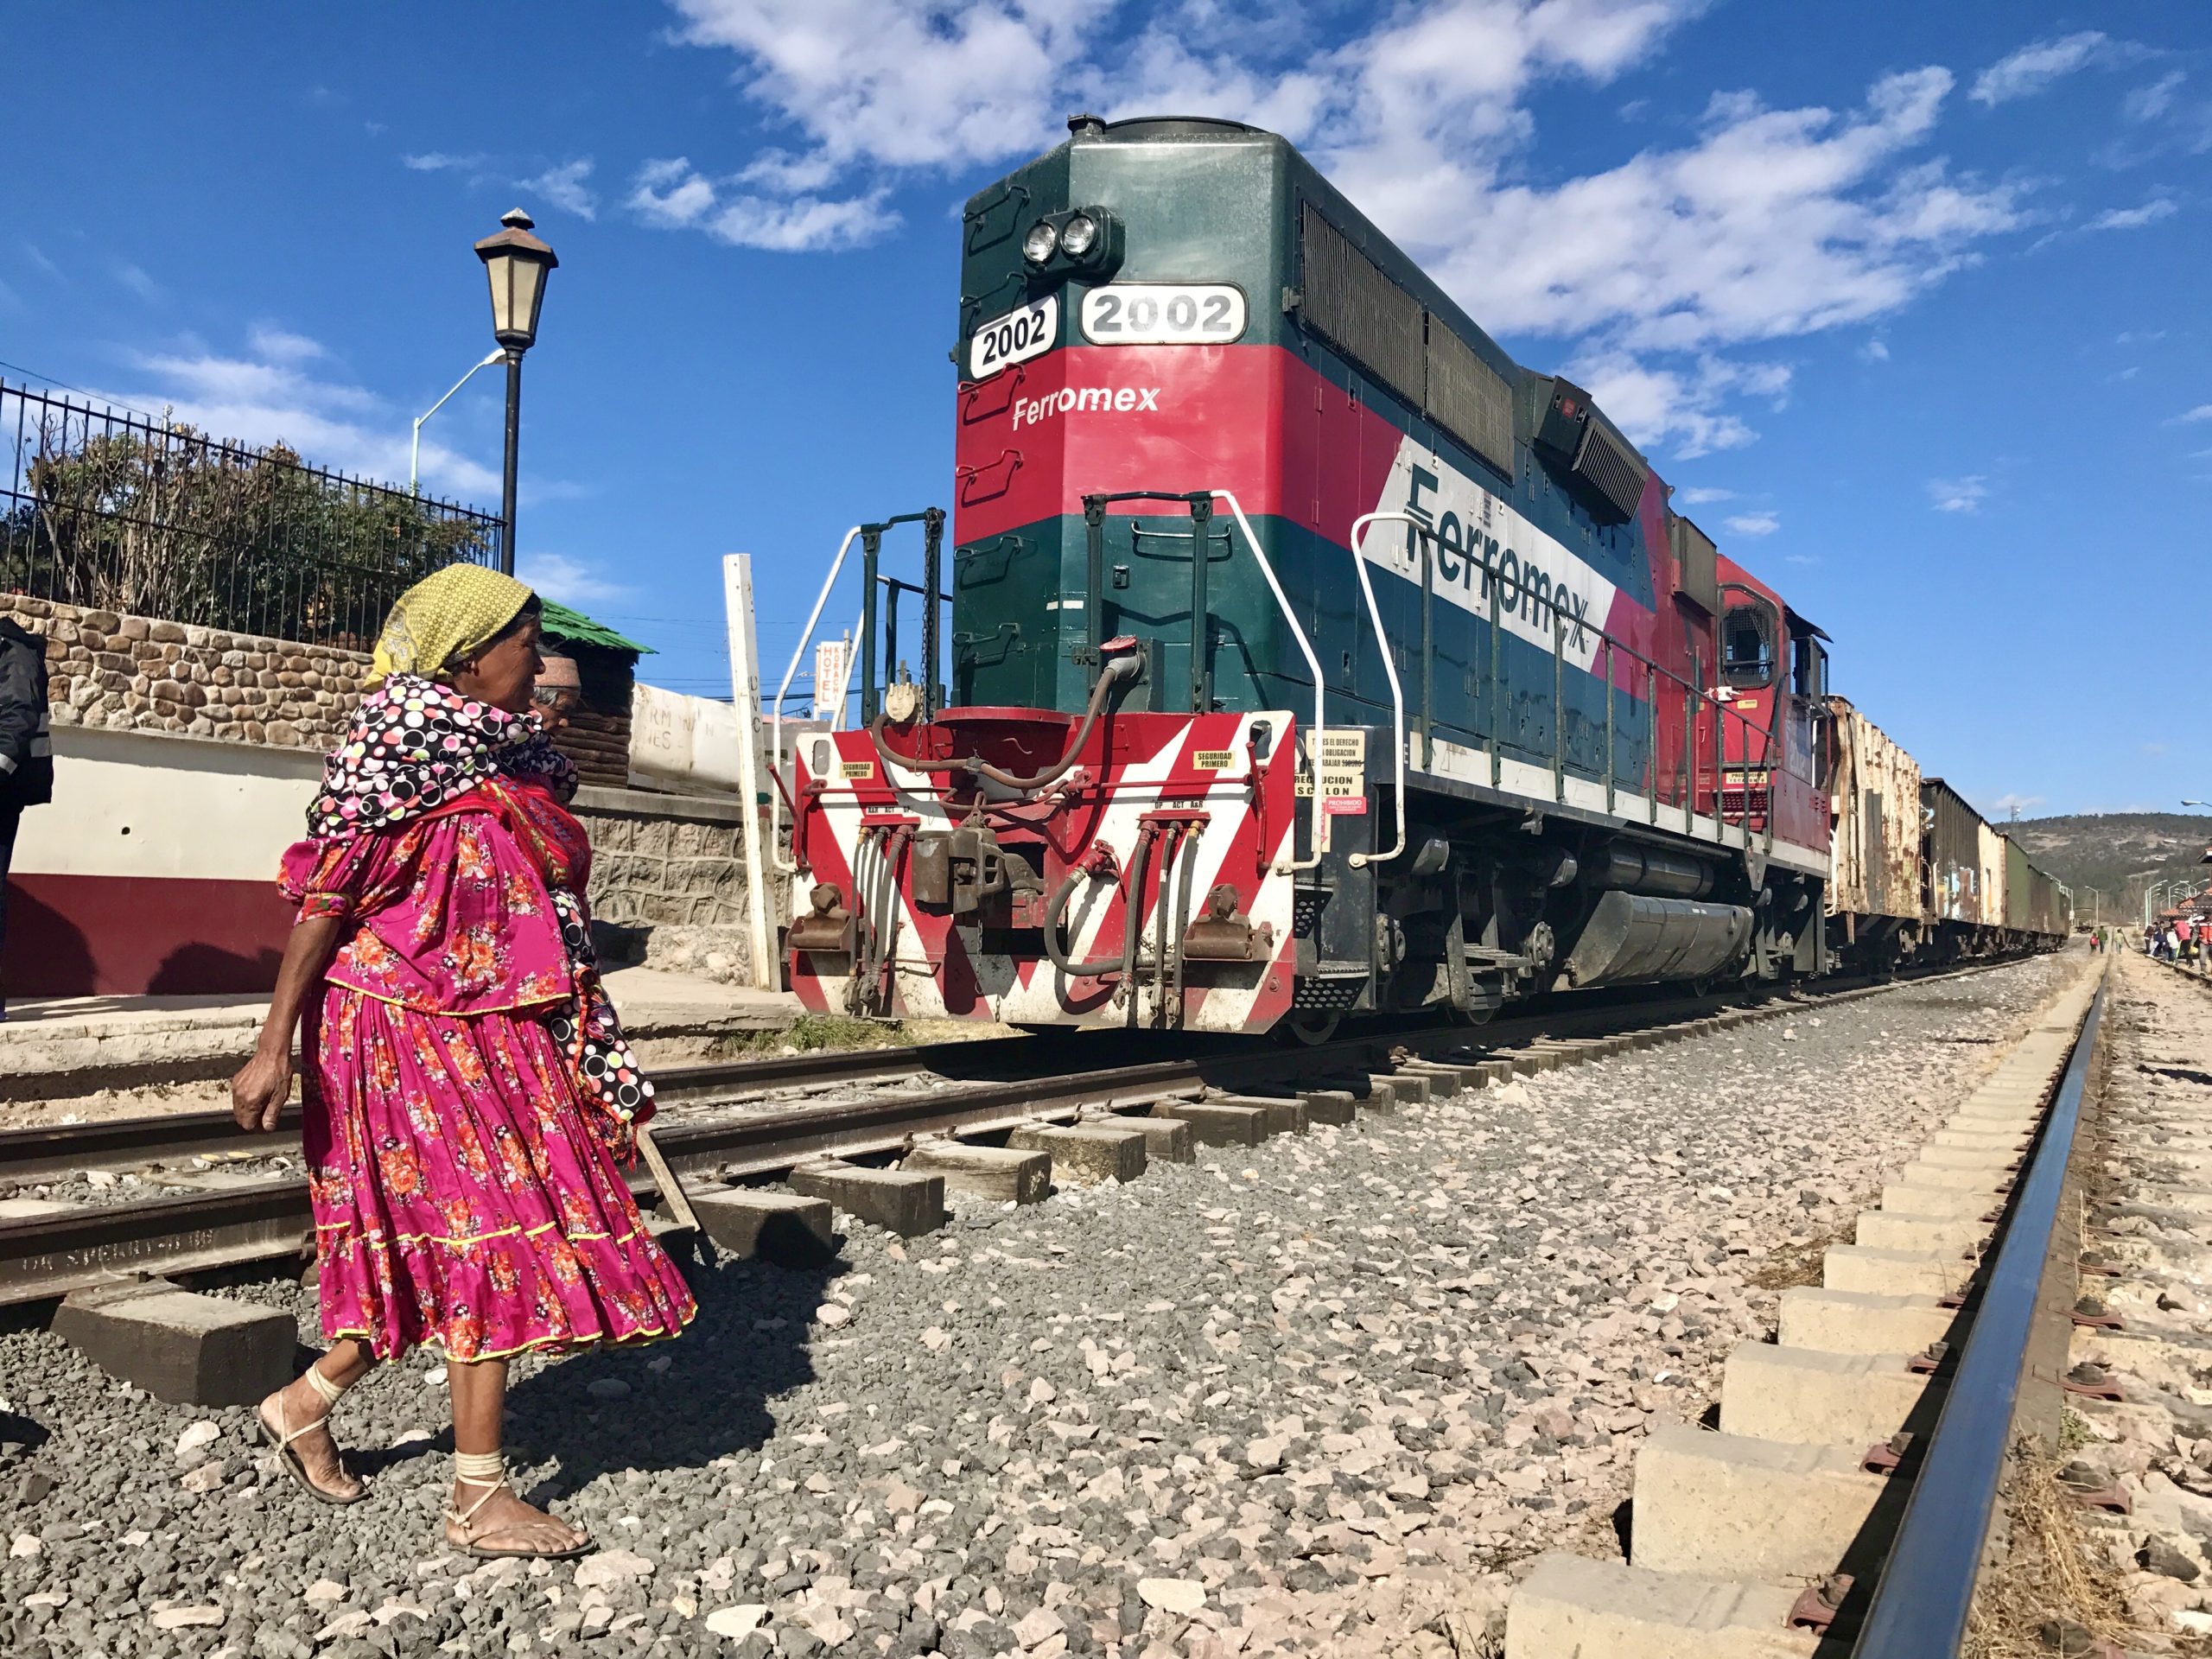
[0, 380, 500, 651]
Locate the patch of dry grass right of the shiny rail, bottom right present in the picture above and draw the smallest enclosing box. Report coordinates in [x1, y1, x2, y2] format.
[1960, 1440, 2128, 1659]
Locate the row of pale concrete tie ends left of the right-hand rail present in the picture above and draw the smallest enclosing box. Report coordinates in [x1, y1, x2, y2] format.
[1506, 973, 2094, 1659]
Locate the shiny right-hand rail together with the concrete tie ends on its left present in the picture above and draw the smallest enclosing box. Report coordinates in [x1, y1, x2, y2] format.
[1506, 967, 2106, 1659]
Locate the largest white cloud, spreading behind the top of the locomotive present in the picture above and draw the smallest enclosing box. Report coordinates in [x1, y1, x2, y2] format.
[658, 0, 2031, 455]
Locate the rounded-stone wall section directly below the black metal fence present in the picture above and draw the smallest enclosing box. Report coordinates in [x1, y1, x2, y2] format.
[0, 593, 370, 750]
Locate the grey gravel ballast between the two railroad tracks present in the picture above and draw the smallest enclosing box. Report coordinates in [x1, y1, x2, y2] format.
[0, 960, 2062, 1659]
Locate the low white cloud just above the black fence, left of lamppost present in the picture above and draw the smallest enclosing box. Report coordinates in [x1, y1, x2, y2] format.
[99, 327, 500, 502]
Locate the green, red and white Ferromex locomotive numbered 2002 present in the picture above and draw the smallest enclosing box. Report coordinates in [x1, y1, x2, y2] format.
[779, 118, 2052, 1035]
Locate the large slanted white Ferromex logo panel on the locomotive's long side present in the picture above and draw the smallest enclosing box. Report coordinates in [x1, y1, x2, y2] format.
[1365, 448, 1615, 668]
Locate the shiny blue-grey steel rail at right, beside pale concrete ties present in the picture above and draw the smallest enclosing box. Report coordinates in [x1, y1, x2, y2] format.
[1852, 969, 2106, 1659]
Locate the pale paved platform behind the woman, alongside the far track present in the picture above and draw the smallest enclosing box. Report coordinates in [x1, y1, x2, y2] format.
[0, 967, 798, 1099]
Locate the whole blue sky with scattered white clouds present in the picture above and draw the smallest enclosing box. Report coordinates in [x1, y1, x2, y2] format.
[0, 0, 2212, 814]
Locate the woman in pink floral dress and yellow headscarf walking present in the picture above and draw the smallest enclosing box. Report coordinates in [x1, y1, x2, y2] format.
[232, 566, 695, 1557]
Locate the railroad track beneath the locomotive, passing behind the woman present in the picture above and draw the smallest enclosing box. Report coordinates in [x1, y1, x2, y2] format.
[0, 963, 2035, 1307]
